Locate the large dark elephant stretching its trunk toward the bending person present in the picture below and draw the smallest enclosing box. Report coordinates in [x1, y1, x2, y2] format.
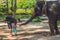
[21, 0, 60, 35]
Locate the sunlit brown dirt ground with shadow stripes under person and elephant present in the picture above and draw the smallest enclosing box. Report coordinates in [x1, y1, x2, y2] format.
[0, 21, 60, 40]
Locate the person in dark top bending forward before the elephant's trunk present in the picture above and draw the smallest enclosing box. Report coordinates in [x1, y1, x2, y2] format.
[6, 15, 20, 36]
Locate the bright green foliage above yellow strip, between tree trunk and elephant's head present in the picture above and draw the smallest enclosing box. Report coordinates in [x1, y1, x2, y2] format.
[17, 0, 36, 9]
